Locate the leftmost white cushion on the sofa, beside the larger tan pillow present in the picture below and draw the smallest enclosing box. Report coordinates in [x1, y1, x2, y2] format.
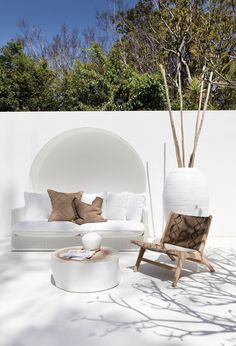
[24, 192, 52, 220]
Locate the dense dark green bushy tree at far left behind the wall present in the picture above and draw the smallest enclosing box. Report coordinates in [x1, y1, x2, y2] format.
[0, 42, 57, 111]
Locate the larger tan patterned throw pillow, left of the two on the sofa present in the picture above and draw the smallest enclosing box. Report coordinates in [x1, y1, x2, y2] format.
[47, 190, 83, 221]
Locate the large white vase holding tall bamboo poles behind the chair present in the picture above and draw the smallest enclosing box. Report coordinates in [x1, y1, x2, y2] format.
[161, 65, 213, 217]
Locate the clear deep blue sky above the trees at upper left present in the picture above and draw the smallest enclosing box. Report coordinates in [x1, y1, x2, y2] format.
[0, 0, 137, 47]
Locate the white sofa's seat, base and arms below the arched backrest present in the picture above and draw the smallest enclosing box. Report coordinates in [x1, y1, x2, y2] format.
[12, 193, 148, 251]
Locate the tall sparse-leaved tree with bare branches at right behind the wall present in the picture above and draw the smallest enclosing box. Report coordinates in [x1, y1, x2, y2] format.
[110, 0, 236, 108]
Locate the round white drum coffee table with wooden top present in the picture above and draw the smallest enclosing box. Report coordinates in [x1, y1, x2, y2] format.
[51, 246, 120, 292]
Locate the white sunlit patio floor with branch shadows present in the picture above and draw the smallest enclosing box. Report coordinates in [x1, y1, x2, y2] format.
[0, 238, 236, 346]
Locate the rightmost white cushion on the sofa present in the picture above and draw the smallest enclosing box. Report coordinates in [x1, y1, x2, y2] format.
[126, 192, 145, 221]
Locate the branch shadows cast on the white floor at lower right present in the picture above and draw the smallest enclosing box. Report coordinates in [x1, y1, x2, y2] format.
[74, 249, 236, 345]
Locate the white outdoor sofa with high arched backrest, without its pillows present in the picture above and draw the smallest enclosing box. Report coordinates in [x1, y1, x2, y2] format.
[12, 127, 148, 251]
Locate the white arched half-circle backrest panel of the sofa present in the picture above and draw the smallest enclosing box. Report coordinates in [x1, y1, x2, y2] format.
[30, 127, 146, 192]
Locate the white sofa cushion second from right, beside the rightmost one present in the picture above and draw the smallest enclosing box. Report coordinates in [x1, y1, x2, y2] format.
[106, 192, 128, 221]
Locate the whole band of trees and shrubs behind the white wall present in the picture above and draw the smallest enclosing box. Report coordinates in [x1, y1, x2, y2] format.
[0, 0, 236, 111]
